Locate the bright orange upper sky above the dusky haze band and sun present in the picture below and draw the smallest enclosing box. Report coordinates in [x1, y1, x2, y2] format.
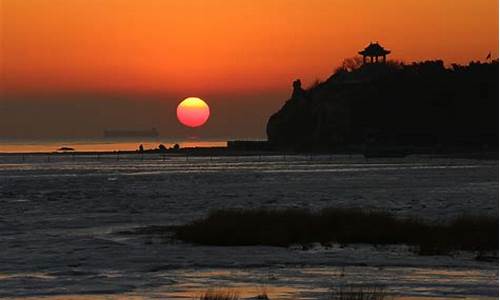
[1, 0, 498, 95]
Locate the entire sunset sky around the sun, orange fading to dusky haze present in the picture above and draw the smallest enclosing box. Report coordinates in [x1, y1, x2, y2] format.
[0, 0, 498, 138]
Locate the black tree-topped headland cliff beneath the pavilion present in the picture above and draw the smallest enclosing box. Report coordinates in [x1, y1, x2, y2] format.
[267, 58, 499, 152]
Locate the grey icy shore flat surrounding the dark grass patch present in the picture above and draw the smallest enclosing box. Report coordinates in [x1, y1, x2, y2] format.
[0, 155, 498, 299]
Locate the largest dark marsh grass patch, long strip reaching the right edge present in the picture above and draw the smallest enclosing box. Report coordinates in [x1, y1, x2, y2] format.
[172, 208, 498, 255]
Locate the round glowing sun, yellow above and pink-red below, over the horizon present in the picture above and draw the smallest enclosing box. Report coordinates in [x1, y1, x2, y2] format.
[177, 97, 210, 127]
